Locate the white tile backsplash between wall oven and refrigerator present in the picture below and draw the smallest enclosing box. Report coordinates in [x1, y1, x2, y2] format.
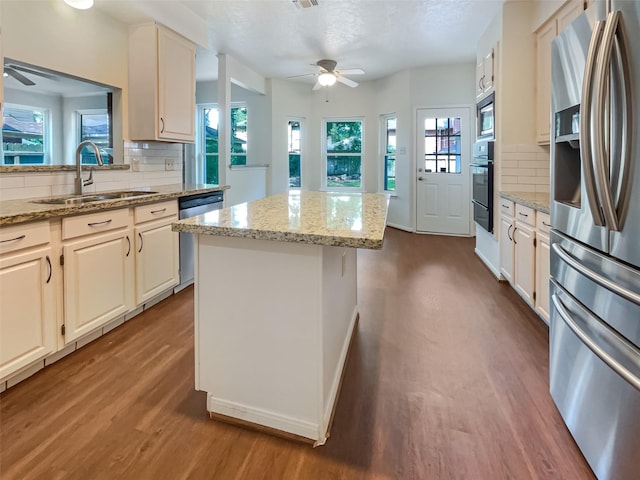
[499, 144, 550, 193]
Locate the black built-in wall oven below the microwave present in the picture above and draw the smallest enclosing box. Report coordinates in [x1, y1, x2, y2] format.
[470, 140, 494, 233]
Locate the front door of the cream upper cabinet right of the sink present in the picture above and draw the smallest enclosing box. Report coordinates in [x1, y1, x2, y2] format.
[158, 28, 196, 142]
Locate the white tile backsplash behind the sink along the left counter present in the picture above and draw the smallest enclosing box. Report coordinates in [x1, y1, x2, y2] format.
[0, 142, 183, 200]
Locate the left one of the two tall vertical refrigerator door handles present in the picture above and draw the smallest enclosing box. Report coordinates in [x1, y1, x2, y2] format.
[580, 20, 604, 226]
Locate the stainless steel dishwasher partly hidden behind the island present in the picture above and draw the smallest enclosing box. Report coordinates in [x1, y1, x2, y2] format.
[174, 192, 224, 292]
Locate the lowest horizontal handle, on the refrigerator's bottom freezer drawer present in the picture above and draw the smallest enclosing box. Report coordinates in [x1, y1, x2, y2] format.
[551, 294, 640, 391]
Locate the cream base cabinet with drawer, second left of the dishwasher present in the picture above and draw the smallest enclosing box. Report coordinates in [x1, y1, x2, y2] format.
[61, 208, 134, 344]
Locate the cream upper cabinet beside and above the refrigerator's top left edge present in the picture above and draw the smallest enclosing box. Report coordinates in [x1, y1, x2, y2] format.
[535, 0, 585, 145]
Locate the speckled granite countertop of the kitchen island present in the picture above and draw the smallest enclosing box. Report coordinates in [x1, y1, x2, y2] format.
[172, 190, 389, 249]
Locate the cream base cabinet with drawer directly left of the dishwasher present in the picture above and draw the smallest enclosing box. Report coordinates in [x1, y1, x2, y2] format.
[134, 200, 180, 305]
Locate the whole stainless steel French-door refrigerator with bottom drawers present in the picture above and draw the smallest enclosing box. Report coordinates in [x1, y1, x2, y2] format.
[549, 0, 640, 480]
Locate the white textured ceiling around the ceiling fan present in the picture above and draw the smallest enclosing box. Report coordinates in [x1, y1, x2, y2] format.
[96, 0, 504, 85]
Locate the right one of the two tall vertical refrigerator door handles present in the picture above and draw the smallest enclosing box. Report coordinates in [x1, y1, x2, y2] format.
[594, 10, 622, 231]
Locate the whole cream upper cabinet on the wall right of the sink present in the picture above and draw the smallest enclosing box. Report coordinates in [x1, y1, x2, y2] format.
[129, 23, 196, 142]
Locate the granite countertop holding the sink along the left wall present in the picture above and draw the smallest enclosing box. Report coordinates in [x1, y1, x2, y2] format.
[0, 183, 229, 225]
